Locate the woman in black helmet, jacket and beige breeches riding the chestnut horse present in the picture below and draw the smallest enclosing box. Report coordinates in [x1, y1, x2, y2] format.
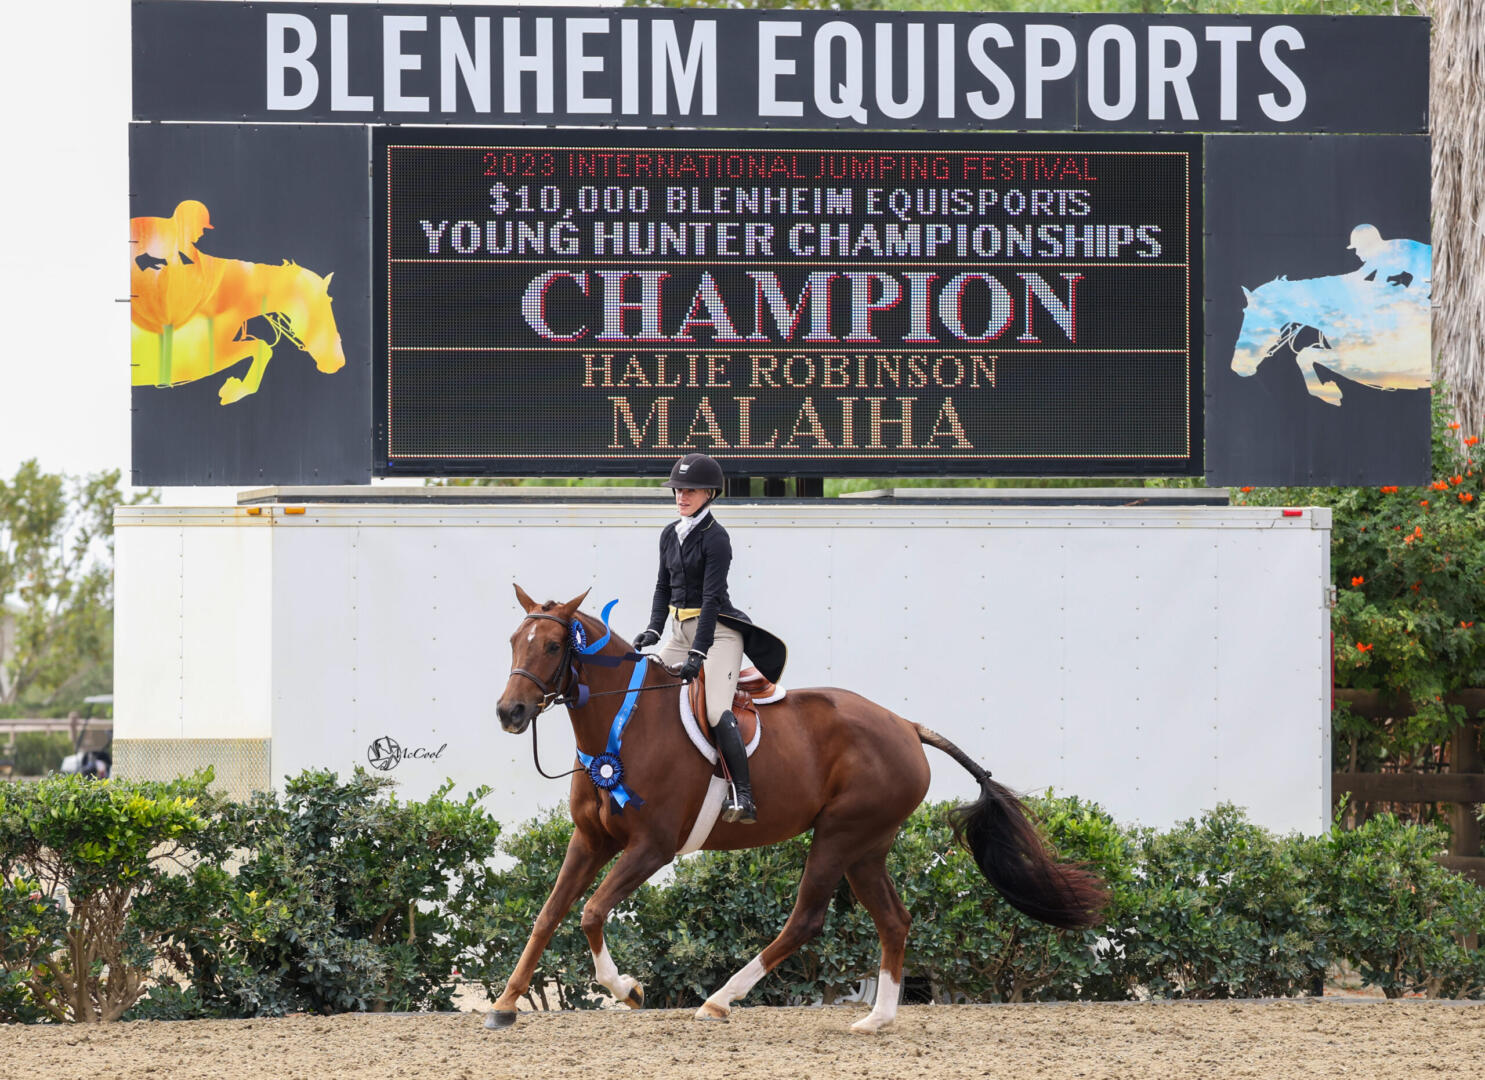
[634, 453, 787, 824]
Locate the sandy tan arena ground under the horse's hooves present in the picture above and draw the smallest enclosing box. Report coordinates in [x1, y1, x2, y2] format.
[0, 1000, 1485, 1080]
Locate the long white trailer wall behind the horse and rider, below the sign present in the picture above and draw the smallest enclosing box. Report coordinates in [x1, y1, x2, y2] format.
[114, 489, 1331, 832]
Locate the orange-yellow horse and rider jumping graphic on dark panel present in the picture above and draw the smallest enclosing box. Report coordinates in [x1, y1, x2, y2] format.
[129, 199, 346, 406]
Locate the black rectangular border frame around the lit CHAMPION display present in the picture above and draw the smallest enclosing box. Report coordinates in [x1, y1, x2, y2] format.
[371, 128, 1204, 477]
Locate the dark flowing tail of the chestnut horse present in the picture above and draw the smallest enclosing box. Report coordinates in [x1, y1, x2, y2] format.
[913, 723, 1108, 930]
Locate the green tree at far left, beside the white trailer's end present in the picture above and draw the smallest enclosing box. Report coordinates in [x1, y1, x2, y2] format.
[0, 459, 157, 706]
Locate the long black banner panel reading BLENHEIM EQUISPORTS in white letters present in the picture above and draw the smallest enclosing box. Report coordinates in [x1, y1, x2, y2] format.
[132, 0, 1429, 134]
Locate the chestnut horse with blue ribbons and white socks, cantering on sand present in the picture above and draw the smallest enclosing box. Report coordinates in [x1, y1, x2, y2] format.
[484, 585, 1108, 1032]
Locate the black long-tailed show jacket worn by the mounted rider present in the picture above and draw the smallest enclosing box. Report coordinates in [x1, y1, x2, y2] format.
[649, 514, 789, 682]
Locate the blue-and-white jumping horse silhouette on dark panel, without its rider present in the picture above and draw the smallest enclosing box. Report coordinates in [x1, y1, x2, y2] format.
[1233, 272, 1430, 407]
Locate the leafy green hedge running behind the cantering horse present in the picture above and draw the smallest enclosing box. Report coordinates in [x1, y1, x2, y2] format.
[0, 770, 1485, 1021]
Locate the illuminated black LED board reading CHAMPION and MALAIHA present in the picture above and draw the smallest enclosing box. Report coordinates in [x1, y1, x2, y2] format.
[373, 128, 1201, 475]
